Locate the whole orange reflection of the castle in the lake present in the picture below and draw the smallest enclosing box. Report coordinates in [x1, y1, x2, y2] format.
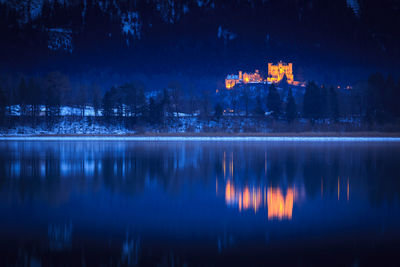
[225, 180, 295, 220]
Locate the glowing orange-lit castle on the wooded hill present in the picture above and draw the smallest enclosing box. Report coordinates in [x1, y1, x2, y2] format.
[225, 61, 305, 90]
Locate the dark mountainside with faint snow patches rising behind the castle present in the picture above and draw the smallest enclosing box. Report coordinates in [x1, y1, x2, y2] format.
[0, 0, 400, 89]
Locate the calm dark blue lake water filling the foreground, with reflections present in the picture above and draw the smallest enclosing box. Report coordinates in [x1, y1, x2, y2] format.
[0, 141, 400, 266]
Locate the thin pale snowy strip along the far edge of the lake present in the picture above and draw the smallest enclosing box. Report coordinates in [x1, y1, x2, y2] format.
[0, 136, 400, 143]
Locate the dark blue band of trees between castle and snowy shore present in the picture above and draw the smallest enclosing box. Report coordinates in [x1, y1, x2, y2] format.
[0, 72, 400, 130]
